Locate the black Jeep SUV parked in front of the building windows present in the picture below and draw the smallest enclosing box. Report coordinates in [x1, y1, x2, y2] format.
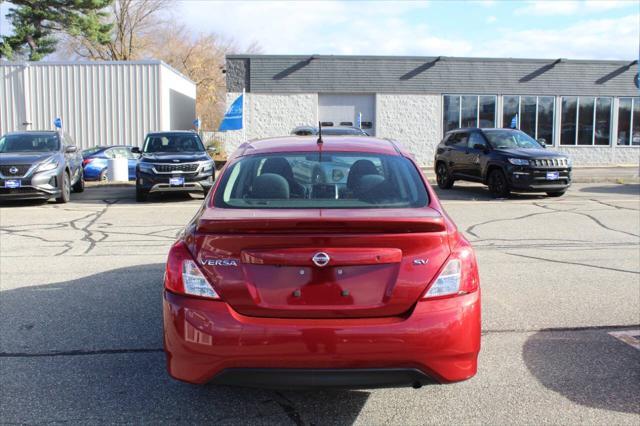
[434, 128, 571, 197]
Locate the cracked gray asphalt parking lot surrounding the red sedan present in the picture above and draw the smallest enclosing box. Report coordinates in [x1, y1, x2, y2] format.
[0, 183, 640, 425]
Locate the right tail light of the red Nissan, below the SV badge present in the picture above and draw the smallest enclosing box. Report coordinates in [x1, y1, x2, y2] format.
[423, 244, 480, 299]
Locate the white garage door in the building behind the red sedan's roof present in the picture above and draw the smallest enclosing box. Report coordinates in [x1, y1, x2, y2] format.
[318, 93, 375, 135]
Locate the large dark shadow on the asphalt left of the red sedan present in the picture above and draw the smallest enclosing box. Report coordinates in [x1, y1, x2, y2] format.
[0, 264, 369, 424]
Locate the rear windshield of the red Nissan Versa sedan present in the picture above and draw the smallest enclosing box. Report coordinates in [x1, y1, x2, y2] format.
[215, 152, 428, 209]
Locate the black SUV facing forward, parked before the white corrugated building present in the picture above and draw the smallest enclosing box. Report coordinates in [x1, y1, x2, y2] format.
[131, 131, 215, 201]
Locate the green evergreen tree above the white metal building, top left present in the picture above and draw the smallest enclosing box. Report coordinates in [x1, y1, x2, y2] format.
[0, 0, 113, 61]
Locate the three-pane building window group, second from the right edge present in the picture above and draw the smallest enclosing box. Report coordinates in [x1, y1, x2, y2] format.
[560, 96, 611, 145]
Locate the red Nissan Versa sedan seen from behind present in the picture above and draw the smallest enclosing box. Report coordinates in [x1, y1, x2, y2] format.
[163, 136, 480, 388]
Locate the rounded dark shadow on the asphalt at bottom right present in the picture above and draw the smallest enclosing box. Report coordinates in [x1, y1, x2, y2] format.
[522, 329, 640, 414]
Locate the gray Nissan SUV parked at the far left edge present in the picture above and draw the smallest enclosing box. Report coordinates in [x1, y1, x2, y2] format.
[0, 131, 84, 203]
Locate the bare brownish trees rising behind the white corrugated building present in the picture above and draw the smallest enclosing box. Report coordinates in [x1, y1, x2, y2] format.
[57, 0, 261, 130]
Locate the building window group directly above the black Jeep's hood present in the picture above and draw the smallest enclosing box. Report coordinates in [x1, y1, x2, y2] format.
[502, 96, 555, 144]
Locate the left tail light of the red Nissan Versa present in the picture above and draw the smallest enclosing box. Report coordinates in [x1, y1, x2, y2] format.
[164, 241, 220, 299]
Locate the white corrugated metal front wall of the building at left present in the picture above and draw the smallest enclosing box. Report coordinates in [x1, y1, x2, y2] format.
[0, 61, 163, 148]
